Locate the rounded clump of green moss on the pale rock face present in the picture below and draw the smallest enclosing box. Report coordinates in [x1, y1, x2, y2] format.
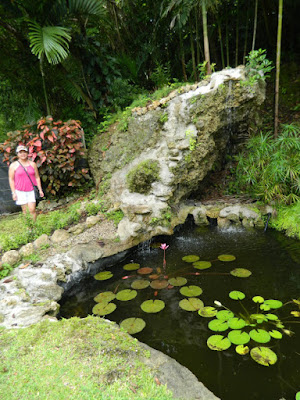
[126, 160, 159, 194]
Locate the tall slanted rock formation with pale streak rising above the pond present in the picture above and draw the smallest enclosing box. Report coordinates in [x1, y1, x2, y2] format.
[89, 67, 265, 240]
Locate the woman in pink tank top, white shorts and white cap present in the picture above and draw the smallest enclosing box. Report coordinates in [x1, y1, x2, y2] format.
[8, 145, 44, 221]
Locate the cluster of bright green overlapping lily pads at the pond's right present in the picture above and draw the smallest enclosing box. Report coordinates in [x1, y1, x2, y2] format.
[202, 290, 284, 366]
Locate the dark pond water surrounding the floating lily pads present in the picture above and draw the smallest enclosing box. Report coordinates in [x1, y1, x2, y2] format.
[61, 224, 300, 400]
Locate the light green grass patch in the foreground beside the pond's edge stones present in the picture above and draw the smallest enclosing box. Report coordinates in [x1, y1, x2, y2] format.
[0, 316, 173, 400]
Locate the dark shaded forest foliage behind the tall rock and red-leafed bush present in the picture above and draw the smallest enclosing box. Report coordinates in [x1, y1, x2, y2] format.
[0, 0, 300, 139]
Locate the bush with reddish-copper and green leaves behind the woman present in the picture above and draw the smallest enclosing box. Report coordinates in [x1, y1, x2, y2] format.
[0, 116, 90, 195]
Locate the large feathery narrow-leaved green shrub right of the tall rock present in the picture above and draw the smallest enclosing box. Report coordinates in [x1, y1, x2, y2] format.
[236, 125, 300, 204]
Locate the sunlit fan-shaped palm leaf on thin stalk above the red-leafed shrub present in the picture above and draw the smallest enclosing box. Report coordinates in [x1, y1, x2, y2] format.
[28, 22, 71, 115]
